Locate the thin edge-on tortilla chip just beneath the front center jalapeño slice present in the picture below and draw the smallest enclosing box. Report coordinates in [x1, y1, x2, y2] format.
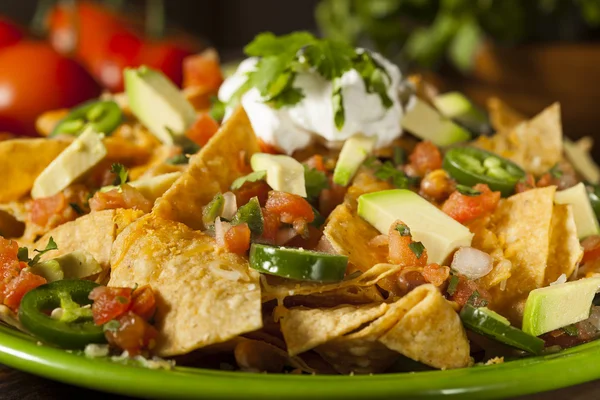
[261, 264, 403, 303]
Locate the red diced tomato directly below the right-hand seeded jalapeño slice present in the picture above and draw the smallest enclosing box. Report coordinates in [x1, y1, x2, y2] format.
[442, 183, 500, 223]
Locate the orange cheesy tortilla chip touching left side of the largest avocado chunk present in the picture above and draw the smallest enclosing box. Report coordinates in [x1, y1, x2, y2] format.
[323, 203, 388, 271]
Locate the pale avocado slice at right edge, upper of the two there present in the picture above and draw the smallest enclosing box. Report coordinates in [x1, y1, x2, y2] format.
[554, 182, 600, 239]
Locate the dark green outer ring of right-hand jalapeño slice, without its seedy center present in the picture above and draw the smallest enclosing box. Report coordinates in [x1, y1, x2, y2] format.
[442, 147, 525, 197]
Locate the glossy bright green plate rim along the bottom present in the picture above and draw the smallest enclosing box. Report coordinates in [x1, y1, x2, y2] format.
[0, 325, 600, 400]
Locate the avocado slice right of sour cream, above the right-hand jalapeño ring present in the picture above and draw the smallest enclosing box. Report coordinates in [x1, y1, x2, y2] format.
[401, 97, 471, 146]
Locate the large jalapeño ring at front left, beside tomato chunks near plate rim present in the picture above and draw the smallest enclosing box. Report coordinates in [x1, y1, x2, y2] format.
[19, 280, 106, 349]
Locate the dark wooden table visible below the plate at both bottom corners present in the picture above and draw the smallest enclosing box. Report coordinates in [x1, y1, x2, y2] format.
[0, 365, 600, 400]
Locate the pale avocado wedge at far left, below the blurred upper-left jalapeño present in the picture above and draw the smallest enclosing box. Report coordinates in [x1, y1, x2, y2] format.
[31, 126, 107, 199]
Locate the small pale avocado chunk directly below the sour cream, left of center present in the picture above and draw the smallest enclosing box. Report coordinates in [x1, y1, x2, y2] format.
[250, 153, 306, 197]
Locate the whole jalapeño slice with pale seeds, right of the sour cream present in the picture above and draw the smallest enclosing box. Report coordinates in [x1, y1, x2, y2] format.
[442, 147, 525, 197]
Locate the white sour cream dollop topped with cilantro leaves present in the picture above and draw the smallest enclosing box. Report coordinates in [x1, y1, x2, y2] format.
[219, 53, 403, 154]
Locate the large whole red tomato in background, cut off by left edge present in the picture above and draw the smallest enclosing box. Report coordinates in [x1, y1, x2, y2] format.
[0, 41, 100, 135]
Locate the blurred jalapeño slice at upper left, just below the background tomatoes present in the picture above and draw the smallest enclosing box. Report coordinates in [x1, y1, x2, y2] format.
[50, 100, 123, 137]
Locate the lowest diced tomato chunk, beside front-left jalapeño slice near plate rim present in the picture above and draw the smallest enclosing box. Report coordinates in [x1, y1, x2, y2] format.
[104, 311, 158, 356]
